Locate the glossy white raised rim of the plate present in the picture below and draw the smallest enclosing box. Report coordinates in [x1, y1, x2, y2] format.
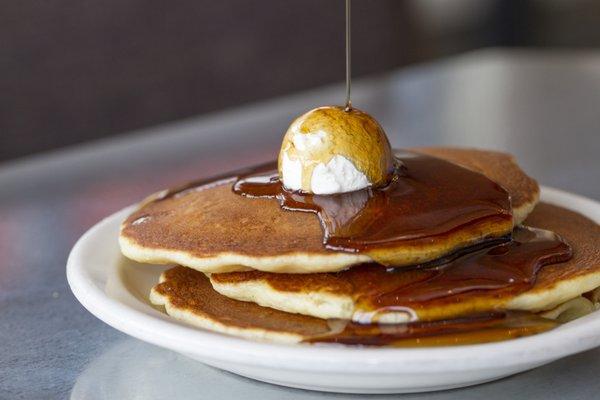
[66, 186, 600, 375]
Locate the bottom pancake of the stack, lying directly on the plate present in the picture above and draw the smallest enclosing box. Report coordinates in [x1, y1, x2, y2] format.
[150, 266, 557, 347]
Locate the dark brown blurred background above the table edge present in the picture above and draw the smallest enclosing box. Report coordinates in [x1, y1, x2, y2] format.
[0, 0, 600, 161]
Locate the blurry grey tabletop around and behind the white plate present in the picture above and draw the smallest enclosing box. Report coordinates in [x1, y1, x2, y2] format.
[0, 50, 600, 399]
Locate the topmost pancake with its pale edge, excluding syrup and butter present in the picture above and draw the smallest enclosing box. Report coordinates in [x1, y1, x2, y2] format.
[119, 148, 539, 273]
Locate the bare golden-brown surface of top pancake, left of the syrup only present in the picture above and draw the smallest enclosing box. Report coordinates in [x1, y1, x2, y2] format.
[122, 183, 333, 257]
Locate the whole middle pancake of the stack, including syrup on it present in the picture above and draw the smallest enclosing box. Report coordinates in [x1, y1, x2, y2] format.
[210, 203, 600, 322]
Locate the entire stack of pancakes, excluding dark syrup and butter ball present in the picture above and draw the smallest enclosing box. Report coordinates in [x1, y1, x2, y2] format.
[119, 148, 600, 342]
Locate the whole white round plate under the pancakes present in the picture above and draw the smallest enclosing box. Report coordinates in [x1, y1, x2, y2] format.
[67, 188, 600, 393]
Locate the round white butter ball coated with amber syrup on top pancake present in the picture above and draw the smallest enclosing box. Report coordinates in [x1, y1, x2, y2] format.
[278, 106, 394, 194]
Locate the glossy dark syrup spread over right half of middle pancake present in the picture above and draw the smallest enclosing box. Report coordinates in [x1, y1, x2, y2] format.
[335, 227, 572, 322]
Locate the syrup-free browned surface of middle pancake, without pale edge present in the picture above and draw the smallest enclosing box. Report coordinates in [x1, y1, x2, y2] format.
[211, 203, 600, 319]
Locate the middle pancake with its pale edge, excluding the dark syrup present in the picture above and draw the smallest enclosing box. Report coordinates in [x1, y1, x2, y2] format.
[211, 203, 600, 322]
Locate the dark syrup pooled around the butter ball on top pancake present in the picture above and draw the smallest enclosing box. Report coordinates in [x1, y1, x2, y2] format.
[233, 151, 512, 252]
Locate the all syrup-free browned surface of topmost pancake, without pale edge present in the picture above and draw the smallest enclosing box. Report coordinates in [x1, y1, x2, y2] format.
[121, 149, 537, 258]
